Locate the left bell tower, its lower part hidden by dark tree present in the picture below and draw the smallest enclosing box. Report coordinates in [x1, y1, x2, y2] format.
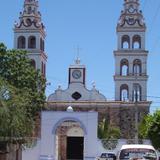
[14, 0, 47, 76]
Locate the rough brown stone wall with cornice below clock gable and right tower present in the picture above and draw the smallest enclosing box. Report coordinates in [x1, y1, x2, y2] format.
[47, 102, 150, 139]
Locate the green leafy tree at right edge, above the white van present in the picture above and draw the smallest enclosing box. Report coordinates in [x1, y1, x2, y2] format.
[139, 110, 160, 149]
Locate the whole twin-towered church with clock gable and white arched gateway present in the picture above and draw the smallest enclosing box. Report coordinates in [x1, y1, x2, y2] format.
[14, 0, 151, 160]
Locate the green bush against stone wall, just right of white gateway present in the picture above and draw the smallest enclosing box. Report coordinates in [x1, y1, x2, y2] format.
[98, 119, 120, 139]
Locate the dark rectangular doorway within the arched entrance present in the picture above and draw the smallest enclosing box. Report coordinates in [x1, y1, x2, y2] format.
[67, 137, 84, 160]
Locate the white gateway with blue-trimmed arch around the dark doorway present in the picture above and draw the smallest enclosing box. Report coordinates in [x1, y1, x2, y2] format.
[23, 111, 98, 160]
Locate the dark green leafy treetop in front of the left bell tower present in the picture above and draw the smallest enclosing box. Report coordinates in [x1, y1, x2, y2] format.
[0, 43, 45, 116]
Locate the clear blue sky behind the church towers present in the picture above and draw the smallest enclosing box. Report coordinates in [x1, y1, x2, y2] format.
[0, 0, 160, 112]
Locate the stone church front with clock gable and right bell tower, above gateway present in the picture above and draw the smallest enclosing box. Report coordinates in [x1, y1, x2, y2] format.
[47, 0, 151, 138]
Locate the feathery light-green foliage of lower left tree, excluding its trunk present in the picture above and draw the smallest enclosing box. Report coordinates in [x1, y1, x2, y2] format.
[0, 79, 34, 142]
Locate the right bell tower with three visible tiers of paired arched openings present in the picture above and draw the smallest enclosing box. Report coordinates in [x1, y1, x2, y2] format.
[114, 0, 148, 102]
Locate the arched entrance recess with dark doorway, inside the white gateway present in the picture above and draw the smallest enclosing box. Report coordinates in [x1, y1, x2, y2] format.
[55, 120, 85, 160]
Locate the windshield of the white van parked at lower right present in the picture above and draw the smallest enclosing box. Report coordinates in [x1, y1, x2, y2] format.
[120, 148, 157, 160]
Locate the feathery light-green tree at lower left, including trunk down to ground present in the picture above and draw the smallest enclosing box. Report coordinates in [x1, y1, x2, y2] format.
[0, 79, 35, 159]
